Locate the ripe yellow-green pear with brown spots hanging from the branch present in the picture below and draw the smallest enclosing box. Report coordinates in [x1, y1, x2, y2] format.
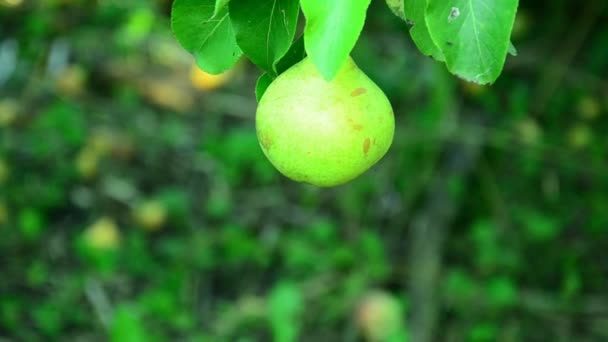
[256, 57, 395, 186]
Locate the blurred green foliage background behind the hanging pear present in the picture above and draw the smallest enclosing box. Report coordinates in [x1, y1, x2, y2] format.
[0, 0, 608, 342]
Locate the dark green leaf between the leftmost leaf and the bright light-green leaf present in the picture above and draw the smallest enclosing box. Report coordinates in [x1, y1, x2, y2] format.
[229, 0, 299, 75]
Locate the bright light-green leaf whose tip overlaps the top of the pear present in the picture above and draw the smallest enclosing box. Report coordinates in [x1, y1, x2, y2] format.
[300, 0, 371, 81]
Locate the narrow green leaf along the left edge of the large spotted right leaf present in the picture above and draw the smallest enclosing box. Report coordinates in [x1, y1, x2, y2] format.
[404, 0, 444, 62]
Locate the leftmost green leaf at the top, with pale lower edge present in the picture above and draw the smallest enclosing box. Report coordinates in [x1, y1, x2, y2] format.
[171, 0, 242, 74]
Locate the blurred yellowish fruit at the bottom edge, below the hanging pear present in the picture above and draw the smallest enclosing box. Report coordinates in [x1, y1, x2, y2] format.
[357, 291, 405, 342]
